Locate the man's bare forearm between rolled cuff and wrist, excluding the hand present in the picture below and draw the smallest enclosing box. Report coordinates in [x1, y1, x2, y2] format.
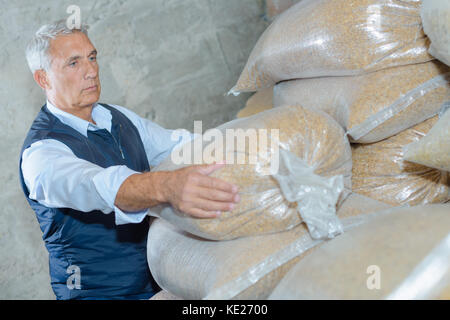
[114, 172, 169, 212]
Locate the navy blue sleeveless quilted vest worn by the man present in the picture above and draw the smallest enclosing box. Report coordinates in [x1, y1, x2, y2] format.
[19, 104, 158, 299]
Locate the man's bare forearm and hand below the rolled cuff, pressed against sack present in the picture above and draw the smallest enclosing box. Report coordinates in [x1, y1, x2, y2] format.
[115, 164, 240, 218]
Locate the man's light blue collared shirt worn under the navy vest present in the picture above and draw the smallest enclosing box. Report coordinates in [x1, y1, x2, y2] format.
[22, 101, 192, 225]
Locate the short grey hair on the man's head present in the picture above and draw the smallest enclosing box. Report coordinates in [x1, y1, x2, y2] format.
[25, 20, 89, 74]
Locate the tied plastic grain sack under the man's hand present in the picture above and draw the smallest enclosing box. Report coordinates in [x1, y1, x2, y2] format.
[150, 106, 351, 240]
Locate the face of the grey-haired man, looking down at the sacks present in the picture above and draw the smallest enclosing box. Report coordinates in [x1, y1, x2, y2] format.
[46, 32, 101, 110]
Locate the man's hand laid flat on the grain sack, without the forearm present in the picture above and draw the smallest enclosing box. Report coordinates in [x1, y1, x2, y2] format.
[163, 164, 240, 218]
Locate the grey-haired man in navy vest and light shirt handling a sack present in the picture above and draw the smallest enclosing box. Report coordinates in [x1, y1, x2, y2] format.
[20, 21, 239, 299]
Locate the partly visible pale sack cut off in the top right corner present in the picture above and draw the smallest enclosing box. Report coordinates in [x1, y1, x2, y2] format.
[420, 0, 450, 66]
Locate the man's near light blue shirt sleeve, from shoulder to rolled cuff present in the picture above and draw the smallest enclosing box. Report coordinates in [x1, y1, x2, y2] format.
[22, 139, 148, 225]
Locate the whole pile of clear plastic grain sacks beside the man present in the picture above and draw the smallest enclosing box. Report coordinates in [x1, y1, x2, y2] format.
[147, 0, 450, 299]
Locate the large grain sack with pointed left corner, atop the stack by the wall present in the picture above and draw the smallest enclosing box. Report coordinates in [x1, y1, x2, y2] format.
[230, 0, 433, 94]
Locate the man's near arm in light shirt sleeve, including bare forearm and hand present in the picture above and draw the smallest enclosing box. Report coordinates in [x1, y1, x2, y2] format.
[22, 139, 237, 224]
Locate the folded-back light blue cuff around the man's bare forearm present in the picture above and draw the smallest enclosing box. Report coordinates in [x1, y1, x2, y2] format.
[92, 165, 148, 225]
